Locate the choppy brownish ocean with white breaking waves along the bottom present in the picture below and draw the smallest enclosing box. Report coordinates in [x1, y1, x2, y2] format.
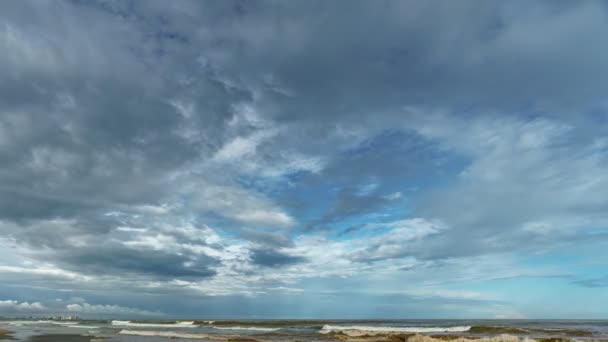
[0, 319, 608, 342]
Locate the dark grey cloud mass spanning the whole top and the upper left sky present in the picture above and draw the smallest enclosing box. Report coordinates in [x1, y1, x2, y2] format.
[2, 1, 604, 224]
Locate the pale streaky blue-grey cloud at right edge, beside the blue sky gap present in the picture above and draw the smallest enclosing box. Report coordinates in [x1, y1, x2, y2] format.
[402, 113, 608, 257]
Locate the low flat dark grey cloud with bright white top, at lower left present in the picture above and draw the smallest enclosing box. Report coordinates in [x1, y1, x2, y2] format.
[0, 220, 218, 279]
